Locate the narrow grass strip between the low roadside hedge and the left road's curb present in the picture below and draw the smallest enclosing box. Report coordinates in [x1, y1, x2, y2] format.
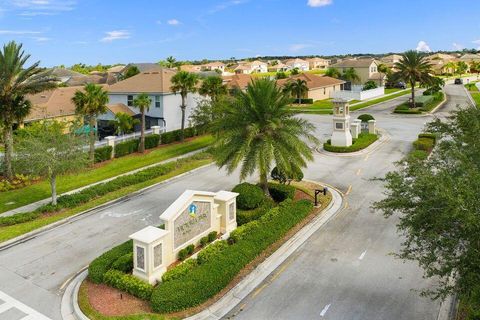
[0, 158, 212, 243]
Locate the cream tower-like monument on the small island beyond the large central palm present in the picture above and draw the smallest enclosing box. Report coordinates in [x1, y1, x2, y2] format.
[331, 99, 352, 147]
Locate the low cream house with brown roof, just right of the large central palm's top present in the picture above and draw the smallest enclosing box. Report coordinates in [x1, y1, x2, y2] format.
[277, 73, 345, 101]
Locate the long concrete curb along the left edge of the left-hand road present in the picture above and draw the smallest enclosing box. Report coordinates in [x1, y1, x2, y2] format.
[0, 162, 214, 251]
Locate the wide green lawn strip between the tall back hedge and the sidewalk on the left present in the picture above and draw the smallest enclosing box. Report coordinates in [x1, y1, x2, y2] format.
[0, 135, 213, 212]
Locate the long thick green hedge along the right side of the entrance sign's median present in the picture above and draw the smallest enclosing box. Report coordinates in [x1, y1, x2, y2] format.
[151, 200, 313, 313]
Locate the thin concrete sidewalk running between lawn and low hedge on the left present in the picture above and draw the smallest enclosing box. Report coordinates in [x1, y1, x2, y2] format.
[0, 148, 207, 217]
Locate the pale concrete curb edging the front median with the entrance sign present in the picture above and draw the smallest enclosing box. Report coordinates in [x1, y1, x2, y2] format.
[62, 184, 344, 320]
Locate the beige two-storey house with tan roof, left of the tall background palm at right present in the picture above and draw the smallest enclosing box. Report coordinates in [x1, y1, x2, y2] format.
[331, 58, 386, 85]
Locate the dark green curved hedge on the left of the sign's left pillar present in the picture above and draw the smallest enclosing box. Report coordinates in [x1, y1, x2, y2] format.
[88, 240, 133, 283]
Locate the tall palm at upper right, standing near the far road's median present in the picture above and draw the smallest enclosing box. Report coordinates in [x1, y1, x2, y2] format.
[395, 50, 433, 108]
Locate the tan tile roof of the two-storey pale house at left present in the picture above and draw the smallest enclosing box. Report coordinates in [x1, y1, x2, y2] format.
[108, 68, 177, 93]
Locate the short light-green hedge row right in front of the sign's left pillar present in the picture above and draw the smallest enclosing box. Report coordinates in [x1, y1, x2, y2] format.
[104, 270, 153, 300]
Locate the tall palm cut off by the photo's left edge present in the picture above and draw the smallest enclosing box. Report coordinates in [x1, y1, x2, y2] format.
[0, 41, 57, 179]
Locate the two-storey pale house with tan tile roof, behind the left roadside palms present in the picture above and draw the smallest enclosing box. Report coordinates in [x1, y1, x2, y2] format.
[99, 68, 201, 131]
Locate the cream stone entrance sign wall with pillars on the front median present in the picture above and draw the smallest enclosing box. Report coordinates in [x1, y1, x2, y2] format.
[130, 190, 238, 284]
